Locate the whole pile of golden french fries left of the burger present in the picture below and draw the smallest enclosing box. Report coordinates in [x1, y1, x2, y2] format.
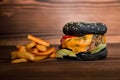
[11, 35, 56, 63]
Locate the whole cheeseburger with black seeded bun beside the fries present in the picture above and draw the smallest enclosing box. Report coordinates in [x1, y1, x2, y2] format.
[57, 22, 108, 61]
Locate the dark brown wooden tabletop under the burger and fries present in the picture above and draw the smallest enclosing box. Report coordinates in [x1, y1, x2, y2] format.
[0, 44, 120, 80]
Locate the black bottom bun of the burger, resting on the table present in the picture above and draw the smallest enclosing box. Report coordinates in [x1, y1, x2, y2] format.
[58, 48, 108, 61]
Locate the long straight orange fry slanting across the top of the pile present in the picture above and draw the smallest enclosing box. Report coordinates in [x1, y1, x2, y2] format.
[28, 35, 50, 47]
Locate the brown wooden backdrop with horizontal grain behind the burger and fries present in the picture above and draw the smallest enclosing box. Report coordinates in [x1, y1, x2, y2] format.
[0, 0, 120, 45]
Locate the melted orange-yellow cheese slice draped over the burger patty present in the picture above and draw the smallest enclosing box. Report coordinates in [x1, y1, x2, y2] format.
[62, 34, 93, 54]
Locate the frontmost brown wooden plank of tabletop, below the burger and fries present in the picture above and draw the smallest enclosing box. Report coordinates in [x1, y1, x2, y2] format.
[0, 61, 120, 80]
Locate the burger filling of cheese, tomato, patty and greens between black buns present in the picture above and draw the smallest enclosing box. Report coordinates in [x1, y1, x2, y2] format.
[61, 34, 106, 54]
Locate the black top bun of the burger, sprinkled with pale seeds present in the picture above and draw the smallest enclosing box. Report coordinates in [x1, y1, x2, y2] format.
[63, 22, 107, 36]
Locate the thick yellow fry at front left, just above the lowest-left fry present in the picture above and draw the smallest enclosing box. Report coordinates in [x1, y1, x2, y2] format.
[17, 52, 34, 61]
